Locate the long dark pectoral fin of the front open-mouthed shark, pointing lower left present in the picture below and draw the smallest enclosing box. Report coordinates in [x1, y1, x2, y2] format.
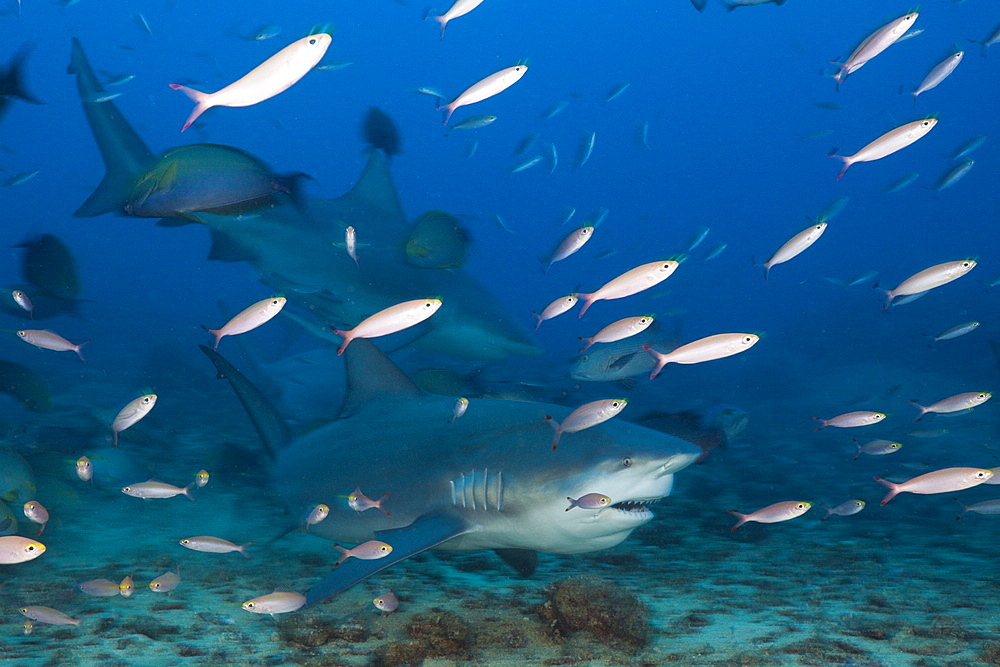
[306, 514, 470, 606]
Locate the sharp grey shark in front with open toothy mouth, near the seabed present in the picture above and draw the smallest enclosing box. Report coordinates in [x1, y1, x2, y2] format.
[201, 340, 702, 604]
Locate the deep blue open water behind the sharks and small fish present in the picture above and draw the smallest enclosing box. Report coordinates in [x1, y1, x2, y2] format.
[0, 0, 1000, 664]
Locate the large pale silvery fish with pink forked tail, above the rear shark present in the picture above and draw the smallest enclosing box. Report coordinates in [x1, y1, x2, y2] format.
[170, 33, 333, 132]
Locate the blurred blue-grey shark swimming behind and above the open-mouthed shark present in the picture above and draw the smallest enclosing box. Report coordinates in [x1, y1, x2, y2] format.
[69, 40, 541, 360]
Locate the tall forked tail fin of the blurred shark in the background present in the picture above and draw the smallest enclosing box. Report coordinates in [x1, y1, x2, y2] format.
[66, 39, 157, 218]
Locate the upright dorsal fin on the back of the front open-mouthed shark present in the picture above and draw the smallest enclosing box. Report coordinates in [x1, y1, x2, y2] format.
[340, 338, 423, 417]
